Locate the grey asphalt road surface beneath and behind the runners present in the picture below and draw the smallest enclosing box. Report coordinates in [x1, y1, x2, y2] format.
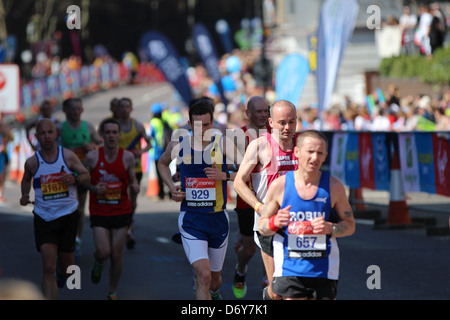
[0, 85, 450, 300]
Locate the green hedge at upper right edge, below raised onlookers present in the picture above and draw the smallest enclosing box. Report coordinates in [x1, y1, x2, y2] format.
[379, 46, 450, 84]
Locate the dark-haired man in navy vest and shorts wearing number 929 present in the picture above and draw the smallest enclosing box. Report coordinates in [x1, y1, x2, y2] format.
[158, 99, 243, 300]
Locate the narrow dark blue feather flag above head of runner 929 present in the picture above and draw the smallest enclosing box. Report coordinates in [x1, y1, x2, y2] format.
[192, 23, 228, 107]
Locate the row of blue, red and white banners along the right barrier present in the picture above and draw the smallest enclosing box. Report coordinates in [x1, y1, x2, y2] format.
[322, 131, 450, 196]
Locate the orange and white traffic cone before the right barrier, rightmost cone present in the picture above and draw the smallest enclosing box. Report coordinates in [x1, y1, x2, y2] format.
[386, 151, 411, 225]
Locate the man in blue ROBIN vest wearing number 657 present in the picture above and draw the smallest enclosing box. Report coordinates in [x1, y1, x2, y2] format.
[259, 130, 355, 299]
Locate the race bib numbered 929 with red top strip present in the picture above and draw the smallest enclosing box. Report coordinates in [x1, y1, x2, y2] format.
[185, 177, 216, 207]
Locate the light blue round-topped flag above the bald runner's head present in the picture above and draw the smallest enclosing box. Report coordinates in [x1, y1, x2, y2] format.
[275, 53, 309, 106]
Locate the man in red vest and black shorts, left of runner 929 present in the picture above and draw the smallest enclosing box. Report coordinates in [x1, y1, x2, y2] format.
[84, 118, 139, 300]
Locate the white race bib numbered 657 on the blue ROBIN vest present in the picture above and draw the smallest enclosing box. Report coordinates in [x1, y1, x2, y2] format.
[288, 221, 327, 259]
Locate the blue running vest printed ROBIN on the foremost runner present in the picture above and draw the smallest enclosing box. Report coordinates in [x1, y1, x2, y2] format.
[273, 171, 339, 280]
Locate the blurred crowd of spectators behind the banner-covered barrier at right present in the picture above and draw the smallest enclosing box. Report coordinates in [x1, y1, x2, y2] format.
[297, 84, 450, 132]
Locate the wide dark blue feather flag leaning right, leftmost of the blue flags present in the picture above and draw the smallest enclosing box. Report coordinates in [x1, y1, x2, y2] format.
[139, 31, 192, 105]
